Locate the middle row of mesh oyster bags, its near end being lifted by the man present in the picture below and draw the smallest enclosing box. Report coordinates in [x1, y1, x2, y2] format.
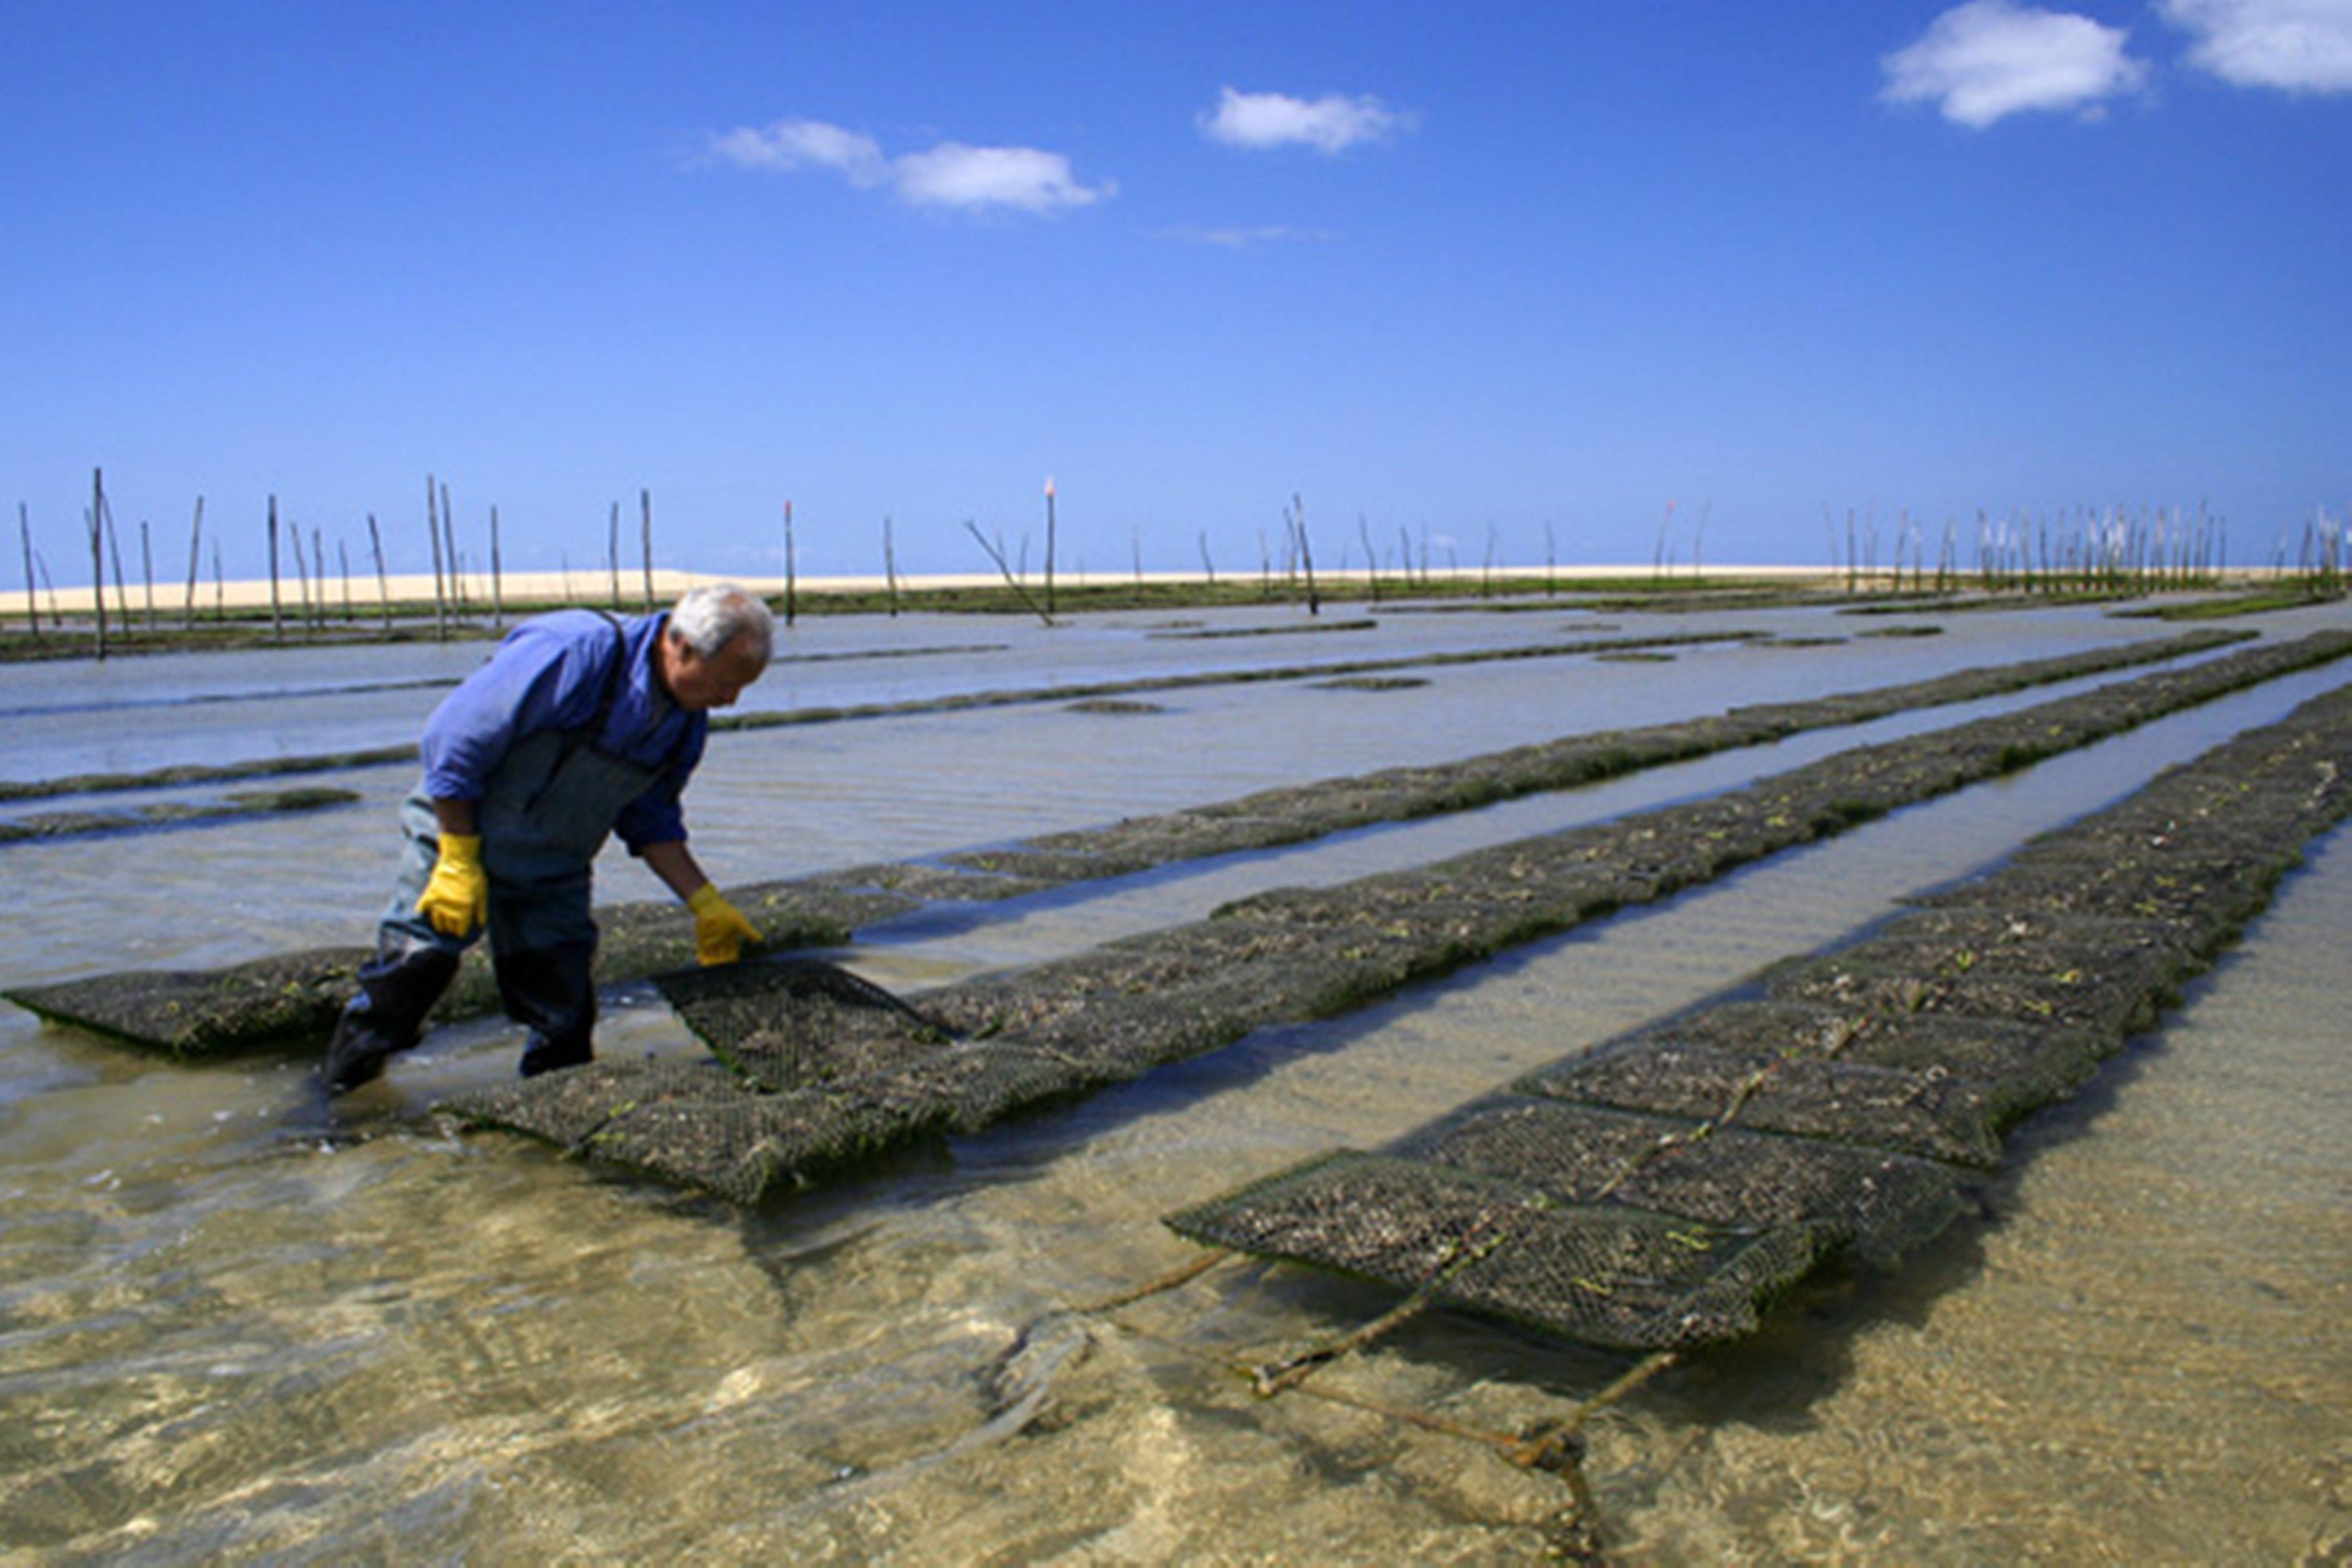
[447, 635, 2352, 1203]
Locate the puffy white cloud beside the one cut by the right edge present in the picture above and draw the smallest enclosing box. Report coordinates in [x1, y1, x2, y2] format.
[1879, 0, 2147, 129]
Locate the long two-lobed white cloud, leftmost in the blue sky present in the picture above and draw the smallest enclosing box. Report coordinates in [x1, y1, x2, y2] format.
[710, 120, 1117, 211]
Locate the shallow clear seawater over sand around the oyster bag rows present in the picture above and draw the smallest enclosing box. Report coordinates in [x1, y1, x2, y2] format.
[0, 595, 2352, 1563]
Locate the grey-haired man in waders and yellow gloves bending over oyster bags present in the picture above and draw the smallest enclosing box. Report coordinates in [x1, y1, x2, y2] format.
[320, 586, 774, 1093]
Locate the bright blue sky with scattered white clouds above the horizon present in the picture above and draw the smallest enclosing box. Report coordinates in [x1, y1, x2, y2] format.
[0, 0, 2352, 586]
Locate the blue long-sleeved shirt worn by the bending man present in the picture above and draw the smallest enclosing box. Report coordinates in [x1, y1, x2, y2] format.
[421, 609, 710, 853]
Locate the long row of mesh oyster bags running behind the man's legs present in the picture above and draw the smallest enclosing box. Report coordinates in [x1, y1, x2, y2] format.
[0, 633, 2244, 1058]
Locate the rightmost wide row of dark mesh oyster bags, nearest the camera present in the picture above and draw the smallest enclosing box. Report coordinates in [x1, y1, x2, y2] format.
[1169, 679, 2352, 1347]
